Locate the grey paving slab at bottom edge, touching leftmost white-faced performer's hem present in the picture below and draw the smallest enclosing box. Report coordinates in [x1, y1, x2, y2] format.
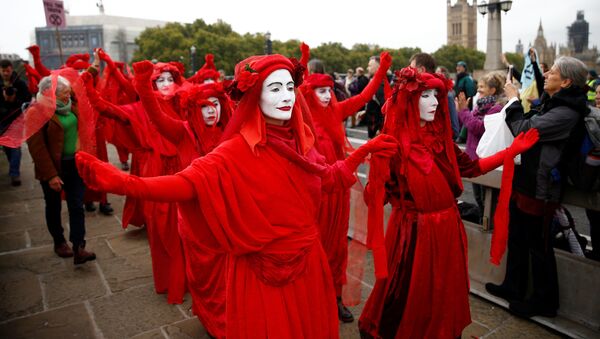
[90, 284, 185, 339]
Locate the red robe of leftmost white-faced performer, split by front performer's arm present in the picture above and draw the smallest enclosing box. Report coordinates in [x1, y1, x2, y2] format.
[96, 99, 187, 304]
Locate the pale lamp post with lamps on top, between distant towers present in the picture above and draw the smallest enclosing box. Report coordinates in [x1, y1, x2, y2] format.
[477, 0, 512, 71]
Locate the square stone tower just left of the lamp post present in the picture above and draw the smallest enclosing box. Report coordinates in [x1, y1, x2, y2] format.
[447, 0, 477, 49]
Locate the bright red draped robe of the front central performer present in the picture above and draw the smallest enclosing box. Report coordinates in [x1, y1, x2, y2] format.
[178, 127, 354, 338]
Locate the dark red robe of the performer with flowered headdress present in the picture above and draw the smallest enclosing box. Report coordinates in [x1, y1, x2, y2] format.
[359, 131, 481, 338]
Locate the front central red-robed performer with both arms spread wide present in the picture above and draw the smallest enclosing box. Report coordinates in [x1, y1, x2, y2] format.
[77, 54, 397, 338]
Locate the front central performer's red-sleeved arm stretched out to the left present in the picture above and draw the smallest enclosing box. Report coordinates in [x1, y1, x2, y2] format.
[75, 152, 196, 202]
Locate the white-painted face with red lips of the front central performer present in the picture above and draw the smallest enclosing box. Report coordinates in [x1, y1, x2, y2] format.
[259, 69, 296, 121]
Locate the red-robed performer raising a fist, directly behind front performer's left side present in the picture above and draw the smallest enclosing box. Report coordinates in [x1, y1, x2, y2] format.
[133, 61, 232, 338]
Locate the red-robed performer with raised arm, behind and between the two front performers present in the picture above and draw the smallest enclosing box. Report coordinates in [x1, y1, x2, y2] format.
[300, 53, 392, 322]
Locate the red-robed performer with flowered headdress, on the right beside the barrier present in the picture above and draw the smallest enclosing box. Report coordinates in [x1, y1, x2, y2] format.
[359, 67, 537, 338]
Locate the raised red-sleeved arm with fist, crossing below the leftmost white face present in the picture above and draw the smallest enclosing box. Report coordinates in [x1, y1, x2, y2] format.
[133, 60, 186, 145]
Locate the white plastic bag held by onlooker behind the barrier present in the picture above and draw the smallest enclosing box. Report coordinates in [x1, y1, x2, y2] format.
[475, 104, 521, 165]
